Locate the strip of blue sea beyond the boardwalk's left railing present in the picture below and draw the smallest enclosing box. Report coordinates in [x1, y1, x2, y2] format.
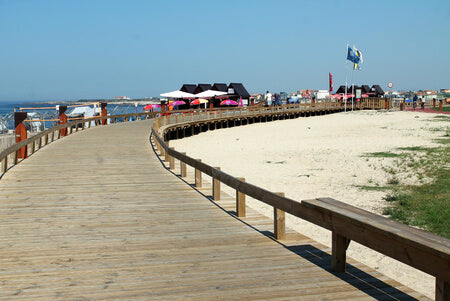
[0, 101, 152, 130]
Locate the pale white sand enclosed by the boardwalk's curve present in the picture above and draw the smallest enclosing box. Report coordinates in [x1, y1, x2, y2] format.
[171, 111, 449, 298]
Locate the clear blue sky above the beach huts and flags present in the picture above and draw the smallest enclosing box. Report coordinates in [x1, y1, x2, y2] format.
[0, 0, 450, 101]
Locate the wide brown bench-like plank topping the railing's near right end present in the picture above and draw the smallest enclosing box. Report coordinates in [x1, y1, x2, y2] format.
[302, 199, 450, 281]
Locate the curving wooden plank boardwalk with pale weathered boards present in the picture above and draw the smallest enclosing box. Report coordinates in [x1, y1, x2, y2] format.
[0, 121, 427, 300]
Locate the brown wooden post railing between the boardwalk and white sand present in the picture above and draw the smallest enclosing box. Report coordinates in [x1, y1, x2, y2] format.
[152, 103, 450, 300]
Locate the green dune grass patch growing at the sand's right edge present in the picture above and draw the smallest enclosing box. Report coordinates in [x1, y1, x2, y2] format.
[383, 135, 450, 238]
